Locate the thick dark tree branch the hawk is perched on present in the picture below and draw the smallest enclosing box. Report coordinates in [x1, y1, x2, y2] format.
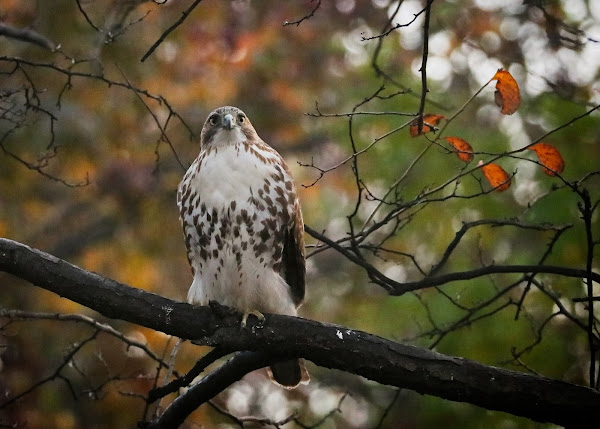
[0, 239, 600, 427]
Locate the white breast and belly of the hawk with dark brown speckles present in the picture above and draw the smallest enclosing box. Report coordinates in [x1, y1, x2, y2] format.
[178, 143, 296, 314]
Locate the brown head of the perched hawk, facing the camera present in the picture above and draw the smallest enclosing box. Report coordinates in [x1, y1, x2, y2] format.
[200, 106, 258, 148]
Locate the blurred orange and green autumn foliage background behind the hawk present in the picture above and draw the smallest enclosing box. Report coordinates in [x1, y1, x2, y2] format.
[0, 0, 600, 429]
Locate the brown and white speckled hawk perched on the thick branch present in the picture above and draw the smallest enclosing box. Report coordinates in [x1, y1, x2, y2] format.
[177, 106, 309, 389]
